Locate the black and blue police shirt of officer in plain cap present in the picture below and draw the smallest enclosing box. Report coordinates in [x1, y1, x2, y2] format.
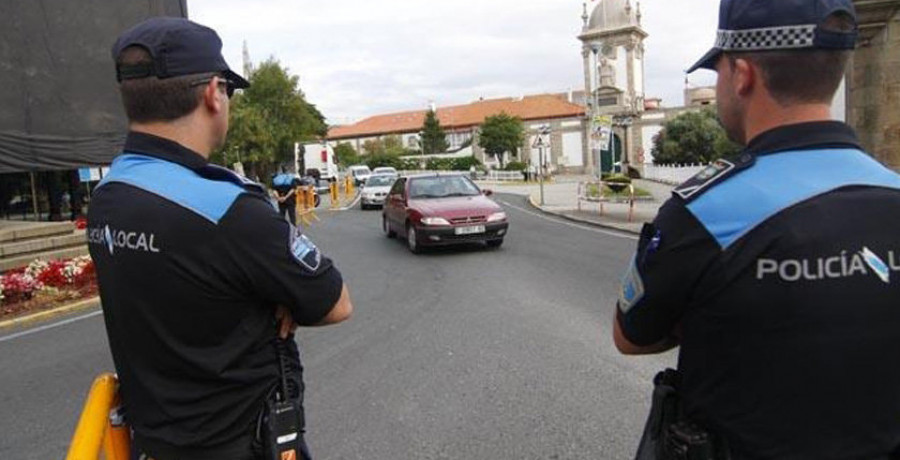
[87, 132, 343, 454]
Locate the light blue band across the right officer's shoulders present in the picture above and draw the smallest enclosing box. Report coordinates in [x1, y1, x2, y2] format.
[687, 149, 900, 250]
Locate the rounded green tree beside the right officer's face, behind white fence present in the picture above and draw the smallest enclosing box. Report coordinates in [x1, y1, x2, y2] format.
[652, 109, 740, 164]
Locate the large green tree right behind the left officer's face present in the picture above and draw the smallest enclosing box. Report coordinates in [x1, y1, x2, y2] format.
[212, 58, 328, 181]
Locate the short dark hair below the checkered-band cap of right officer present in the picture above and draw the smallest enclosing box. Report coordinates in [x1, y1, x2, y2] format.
[726, 12, 856, 106]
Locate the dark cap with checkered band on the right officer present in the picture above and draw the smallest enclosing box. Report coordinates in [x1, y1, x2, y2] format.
[687, 0, 859, 73]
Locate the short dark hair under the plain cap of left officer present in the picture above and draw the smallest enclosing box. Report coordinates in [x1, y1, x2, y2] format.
[116, 46, 207, 123]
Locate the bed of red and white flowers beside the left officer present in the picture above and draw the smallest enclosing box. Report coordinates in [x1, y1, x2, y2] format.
[0, 256, 97, 319]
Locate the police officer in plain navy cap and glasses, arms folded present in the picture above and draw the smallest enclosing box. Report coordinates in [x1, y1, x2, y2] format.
[88, 18, 353, 460]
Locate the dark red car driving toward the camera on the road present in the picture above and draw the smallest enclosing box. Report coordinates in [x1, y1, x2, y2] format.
[381, 174, 509, 253]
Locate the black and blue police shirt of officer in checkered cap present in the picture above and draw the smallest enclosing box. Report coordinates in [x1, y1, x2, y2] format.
[617, 122, 900, 459]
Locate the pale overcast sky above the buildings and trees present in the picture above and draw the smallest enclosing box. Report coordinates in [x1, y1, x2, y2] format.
[188, 0, 718, 124]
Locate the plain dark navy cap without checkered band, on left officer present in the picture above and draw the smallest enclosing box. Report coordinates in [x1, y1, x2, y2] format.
[112, 17, 250, 89]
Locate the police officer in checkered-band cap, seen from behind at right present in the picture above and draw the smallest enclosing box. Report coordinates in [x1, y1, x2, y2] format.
[614, 0, 900, 460]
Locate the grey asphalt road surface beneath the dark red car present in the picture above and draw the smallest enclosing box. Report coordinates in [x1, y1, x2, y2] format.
[0, 195, 675, 460]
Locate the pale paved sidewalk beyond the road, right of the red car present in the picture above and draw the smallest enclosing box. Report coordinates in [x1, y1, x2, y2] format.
[479, 176, 674, 234]
